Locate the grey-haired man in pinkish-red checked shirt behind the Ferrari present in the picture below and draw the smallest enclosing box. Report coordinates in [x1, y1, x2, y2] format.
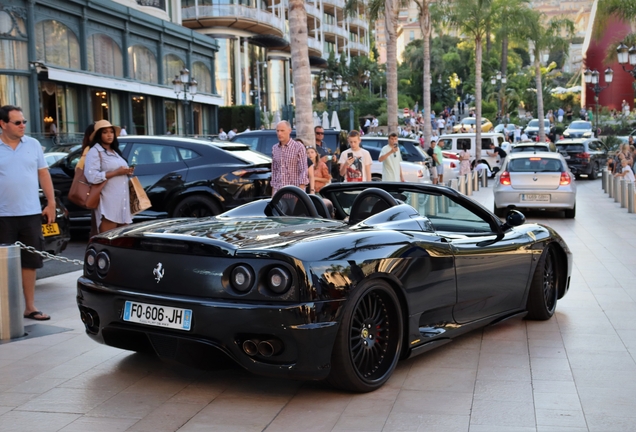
[271, 120, 313, 195]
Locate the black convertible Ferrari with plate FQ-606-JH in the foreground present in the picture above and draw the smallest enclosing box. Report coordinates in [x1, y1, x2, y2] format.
[77, 182, 572, 392]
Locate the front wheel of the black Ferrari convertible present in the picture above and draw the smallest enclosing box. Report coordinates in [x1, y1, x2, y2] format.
[526, 246, 559, 321]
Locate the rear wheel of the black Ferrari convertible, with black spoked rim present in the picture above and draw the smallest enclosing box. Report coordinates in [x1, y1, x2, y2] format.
[327, 279, 404, 392]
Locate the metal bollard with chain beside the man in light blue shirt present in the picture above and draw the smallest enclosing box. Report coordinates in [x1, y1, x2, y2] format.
[0, 245, 24, 340]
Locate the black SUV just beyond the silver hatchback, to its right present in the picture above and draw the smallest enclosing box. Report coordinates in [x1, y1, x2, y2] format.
[556, 138, 607, 180]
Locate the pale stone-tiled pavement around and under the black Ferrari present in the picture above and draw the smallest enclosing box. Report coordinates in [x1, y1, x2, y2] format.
[0, 180, 636, 432]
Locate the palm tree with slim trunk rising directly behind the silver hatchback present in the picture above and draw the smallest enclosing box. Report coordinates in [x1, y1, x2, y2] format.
[522, 10, 574, 142]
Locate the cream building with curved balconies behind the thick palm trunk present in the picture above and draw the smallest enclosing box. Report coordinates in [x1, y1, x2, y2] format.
[181, 0, 370, 117]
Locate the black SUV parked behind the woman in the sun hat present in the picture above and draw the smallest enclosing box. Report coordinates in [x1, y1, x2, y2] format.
[50, 135, 271, 227]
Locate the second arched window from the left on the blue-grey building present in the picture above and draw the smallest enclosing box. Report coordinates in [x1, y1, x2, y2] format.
[35, 20, 80, 69]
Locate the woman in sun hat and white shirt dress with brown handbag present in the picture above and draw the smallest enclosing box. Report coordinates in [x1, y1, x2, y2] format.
[84, 120, 134, 233]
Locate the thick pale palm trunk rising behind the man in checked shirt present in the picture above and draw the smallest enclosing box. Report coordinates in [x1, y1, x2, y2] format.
[289, 0, 316, 146]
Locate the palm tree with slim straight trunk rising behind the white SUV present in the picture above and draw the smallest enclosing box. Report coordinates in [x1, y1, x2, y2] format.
[447, 0, 493, 160]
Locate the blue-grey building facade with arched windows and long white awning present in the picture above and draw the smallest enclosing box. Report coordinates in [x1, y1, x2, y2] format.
[0, 0, 223, 145]
